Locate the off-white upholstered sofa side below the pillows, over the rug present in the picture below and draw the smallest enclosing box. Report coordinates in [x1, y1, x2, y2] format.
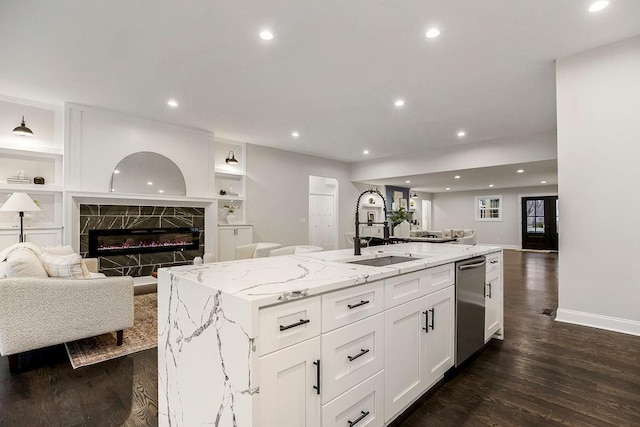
[0, 277, 133, 356]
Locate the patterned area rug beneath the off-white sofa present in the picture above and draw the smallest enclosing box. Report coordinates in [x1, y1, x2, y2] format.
[64, 293, 158, 369]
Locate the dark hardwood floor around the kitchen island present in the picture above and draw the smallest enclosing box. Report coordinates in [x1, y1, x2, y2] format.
[0, 251, 640, 427]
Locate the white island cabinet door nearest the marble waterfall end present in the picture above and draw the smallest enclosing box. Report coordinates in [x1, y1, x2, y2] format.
[257, 337, 321, 427]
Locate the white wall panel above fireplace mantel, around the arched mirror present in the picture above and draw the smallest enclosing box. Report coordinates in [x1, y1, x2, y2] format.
[65, 104, 215, 197]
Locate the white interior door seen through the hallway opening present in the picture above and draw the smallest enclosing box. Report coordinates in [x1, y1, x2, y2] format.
[309, 194, 335, 250]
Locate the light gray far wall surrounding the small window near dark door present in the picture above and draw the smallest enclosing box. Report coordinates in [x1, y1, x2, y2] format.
[431, 185, 558, 249]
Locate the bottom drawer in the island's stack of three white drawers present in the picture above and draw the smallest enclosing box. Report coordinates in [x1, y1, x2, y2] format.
[322, 371, 384, 427]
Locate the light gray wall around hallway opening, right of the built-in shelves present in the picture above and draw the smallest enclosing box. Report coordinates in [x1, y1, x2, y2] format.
[247, 144, 360, 248]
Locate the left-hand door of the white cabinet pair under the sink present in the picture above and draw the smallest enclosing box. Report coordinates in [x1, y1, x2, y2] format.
[384, 297, 427, 421]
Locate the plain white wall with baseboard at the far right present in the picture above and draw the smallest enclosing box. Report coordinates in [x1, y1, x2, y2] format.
[556, 37, 640, 335]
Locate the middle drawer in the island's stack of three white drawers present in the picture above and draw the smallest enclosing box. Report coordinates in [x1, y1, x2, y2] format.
[322, 313, 384, 403]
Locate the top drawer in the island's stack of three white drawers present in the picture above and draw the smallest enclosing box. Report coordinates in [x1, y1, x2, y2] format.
[322, 280, 384, 332]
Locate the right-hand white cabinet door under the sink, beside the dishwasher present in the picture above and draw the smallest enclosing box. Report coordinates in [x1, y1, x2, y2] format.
[425, 286, 455, 386]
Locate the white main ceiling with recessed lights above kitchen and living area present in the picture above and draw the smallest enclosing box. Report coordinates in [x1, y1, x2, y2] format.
[0, 0, 640, 187]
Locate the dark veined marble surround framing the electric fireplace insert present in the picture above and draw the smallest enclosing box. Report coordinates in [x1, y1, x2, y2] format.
[80, 204, 205, 277]
